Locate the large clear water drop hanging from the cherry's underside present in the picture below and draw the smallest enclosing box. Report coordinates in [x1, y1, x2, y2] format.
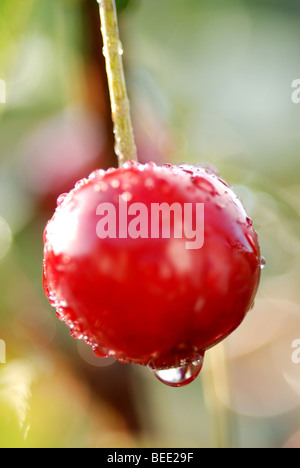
[149, 353, 204, 387]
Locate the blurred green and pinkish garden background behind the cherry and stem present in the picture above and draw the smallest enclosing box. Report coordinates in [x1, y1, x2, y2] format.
[0, 0, 300, 448]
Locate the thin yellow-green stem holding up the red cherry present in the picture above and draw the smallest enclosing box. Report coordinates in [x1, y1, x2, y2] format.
[97, 0, 138, 166]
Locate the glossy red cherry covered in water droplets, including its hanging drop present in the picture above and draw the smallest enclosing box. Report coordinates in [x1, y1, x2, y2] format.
[44, 163, 261, 386]
